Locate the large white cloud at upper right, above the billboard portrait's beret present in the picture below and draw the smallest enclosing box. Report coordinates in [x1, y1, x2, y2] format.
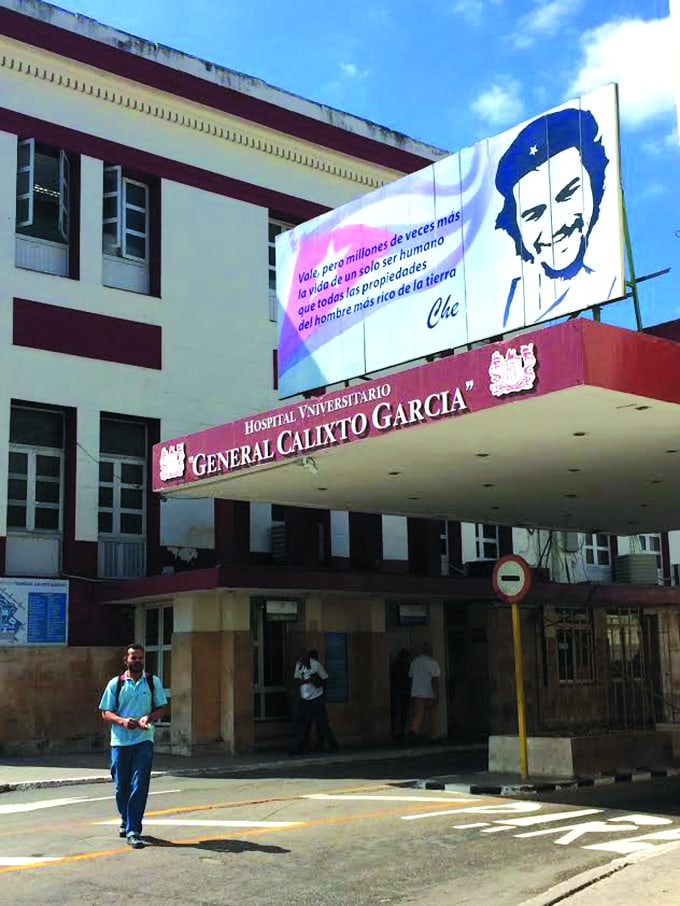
[567, 18, 677, 128]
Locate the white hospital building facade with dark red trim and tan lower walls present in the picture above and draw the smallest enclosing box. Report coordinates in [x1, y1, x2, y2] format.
[0, 0, 680, 753]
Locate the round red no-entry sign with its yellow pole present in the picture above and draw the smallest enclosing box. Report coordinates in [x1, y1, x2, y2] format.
[492, 554, 531, 780]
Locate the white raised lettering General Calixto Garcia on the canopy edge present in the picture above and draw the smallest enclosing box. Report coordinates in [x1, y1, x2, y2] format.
[189, 382, 472, 478]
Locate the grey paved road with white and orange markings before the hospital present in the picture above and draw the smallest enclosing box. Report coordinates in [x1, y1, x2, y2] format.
[0, 762, 680, 906]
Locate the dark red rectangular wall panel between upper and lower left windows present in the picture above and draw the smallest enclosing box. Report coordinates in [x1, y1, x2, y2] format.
[12, 299, 162, 370]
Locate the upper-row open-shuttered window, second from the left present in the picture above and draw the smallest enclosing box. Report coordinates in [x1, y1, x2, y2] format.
[102, 164, 151, 293]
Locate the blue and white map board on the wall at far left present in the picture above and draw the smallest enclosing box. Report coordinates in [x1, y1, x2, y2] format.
[0, 578, 68, 645]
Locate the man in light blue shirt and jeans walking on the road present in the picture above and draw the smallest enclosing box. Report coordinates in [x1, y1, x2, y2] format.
[99, 644, 168, 849]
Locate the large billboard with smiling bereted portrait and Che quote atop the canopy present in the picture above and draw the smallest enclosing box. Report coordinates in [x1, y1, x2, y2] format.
[276, 85, 624, 397]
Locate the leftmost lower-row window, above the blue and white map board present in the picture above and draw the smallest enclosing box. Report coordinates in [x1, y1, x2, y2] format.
[7, 406, 64, 534]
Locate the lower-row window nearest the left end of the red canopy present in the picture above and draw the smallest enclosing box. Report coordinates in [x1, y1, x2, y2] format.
[99, 418, 147, 540]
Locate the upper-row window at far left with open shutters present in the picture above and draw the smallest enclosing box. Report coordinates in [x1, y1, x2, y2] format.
[16, 138, 76, 276]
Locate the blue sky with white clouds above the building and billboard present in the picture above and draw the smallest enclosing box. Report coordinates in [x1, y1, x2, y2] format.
[50, 0, 680, 326]
